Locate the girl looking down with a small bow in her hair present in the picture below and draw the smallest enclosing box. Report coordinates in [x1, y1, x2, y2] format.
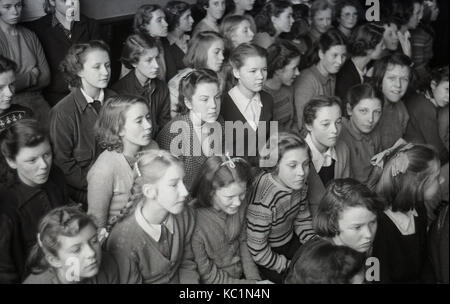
[192, 156, 270, 284]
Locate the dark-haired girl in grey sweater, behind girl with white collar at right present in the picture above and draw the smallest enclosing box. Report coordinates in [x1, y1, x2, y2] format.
[294, 29, 347, 129]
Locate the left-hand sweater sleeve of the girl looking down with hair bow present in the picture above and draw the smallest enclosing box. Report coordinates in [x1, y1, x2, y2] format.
[192, 230, 254, 284]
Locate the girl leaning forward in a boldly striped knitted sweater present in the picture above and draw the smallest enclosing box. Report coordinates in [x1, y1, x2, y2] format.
[247, 132, 315, 283]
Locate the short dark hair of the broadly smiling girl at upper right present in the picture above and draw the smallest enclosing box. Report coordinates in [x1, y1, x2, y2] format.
[372, 53, 413, 91]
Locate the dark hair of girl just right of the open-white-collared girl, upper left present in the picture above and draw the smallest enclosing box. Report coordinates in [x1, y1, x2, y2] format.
[120, 34, 159, 70]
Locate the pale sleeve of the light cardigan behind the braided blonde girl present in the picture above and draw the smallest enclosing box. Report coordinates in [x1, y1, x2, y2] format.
[87, 155, 115, 228]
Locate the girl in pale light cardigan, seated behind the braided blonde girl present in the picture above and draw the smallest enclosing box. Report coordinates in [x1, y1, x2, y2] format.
[86, 95, 158, 228]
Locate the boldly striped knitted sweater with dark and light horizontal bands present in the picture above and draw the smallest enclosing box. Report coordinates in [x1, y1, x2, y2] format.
[247, 173, 315, 273]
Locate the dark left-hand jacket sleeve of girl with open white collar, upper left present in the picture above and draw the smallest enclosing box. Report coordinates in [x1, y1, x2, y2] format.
[50, 110, 91, 189]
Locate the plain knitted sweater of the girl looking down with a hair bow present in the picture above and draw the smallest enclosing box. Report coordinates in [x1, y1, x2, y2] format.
[192, 206, 261, 284]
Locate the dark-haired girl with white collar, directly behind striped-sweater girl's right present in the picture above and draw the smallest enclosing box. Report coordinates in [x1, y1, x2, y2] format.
[303, 96, 351, 186]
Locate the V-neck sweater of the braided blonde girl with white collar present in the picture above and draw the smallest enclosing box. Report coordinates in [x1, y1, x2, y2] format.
[107, 206, 199, 284]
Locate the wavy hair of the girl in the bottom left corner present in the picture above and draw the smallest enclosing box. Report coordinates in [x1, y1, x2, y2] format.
[27, 206, 97, 274]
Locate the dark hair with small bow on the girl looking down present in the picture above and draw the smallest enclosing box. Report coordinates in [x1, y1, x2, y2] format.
[192, 156, 251, 208]
